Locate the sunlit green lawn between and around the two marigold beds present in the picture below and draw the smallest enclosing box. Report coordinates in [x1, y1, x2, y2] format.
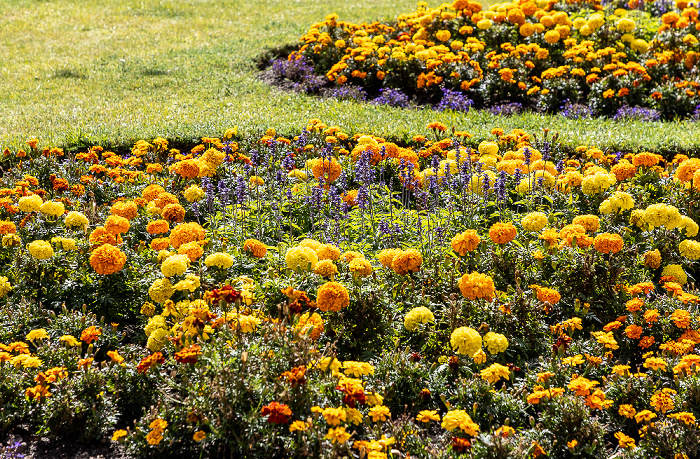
[0, 0, 700, 153]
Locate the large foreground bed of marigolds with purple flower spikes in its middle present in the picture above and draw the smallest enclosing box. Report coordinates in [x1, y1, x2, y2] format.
[0, 124, 700, 458]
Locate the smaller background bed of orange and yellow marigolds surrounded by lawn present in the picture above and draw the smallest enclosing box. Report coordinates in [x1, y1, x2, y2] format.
[284, 0, 700, 119]
